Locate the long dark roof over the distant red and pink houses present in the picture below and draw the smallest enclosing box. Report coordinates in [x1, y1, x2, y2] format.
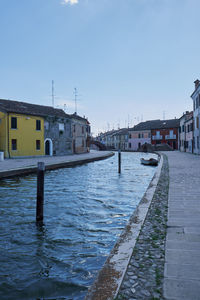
[129, 119, 180, 131]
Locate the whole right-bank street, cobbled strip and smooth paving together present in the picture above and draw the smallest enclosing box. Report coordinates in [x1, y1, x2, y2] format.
[118, 151, 200, 300]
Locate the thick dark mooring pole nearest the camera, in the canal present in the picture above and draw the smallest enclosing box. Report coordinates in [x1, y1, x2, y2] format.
[36, 162, 45, 223]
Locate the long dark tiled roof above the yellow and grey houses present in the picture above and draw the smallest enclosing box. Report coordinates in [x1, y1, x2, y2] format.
[0, 99, 70, 118]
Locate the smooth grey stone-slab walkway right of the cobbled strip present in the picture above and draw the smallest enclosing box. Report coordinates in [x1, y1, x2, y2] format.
[164, 152, 200, 300]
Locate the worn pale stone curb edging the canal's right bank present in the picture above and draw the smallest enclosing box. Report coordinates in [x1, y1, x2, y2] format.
[85, 155, 163, 300]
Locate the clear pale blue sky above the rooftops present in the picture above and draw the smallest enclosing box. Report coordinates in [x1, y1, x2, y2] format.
[0, 0, 200, 135]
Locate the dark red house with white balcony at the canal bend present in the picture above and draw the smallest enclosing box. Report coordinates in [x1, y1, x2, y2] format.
[151, 119, 180, 150]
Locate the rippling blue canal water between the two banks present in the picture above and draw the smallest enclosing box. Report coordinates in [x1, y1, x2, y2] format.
[0, 153, 156, 300]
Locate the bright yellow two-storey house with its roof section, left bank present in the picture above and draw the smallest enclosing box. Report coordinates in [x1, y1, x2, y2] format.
[0, 99, 44, 158]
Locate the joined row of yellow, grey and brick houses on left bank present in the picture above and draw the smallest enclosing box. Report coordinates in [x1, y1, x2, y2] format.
[0, 99, 90, 158]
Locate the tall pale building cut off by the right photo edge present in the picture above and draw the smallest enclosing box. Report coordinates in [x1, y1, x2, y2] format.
[191, 79, 200, 154]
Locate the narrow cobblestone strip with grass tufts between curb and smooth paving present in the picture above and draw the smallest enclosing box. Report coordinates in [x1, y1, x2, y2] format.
[116, 156, 169, 300]
